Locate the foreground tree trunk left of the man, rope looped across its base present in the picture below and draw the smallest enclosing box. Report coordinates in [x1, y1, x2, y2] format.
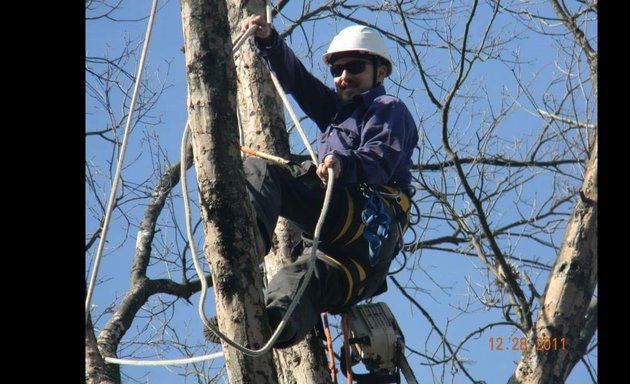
[181, 0, 277, 383]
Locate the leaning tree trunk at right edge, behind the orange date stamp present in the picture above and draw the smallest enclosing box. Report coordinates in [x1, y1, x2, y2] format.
[509, 131, 597, 384]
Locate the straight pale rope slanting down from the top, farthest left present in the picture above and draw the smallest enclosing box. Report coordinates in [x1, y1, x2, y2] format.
[85, 0, 158, 322]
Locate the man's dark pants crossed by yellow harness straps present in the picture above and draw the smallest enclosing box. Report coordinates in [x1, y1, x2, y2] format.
[244, 157, 399, 348]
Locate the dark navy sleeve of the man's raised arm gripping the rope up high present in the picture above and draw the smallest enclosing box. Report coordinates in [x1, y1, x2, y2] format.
[255, 28, 336, 132]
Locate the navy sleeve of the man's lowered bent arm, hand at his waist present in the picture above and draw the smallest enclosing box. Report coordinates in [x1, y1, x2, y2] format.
[332, 99, 415, 185]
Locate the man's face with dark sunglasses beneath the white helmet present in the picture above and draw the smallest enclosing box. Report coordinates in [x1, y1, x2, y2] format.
[332, 57, 386, 102]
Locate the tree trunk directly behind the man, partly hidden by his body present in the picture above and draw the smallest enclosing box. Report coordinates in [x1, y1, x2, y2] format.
[228, 0, 332, 384]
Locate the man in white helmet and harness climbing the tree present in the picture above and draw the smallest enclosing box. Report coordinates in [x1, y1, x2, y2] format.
[222, 16, 418, 348]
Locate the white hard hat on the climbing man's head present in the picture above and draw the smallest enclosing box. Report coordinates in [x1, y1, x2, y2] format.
[322, 25, 393, 76]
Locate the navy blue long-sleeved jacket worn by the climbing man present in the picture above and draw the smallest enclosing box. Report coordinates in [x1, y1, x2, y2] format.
[256, 30, 418, 186]
